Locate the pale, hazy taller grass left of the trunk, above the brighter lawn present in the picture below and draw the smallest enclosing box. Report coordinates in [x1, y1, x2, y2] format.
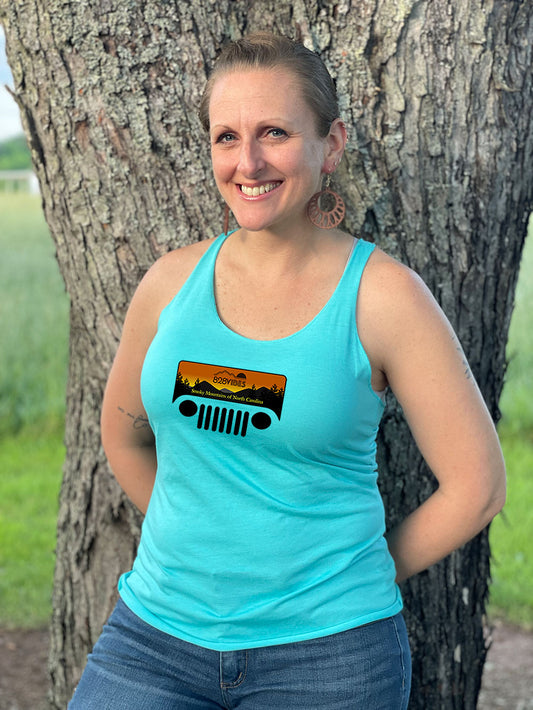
[0, 194, 68, 437]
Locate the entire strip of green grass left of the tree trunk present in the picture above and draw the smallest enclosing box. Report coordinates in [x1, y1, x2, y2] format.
[0, 193, 68, 628]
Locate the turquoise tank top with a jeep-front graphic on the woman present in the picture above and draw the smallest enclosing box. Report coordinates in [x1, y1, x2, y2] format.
[119, 236, 402, 651]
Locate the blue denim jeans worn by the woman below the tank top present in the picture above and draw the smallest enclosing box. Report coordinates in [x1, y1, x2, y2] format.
[68, 600, 411, 710]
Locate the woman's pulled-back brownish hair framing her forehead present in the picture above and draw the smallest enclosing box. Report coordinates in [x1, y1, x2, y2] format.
[199, 32, 339, 137]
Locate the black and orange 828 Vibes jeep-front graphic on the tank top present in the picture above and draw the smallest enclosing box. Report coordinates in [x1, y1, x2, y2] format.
[172, 360, 287, 436]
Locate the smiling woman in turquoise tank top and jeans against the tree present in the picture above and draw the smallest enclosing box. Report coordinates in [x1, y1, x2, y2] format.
[69, 34, 505, 710]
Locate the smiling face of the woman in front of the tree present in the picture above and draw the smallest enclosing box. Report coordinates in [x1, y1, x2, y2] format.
[209, 68, 331, 236]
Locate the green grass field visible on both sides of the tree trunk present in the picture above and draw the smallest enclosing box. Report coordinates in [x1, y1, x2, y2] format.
[0, 194, 533, 628]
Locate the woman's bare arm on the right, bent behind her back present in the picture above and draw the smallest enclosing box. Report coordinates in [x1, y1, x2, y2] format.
[358, 252, 505, 581]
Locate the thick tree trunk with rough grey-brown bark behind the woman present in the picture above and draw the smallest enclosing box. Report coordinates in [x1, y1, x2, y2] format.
[0, 0, 533, 710]
